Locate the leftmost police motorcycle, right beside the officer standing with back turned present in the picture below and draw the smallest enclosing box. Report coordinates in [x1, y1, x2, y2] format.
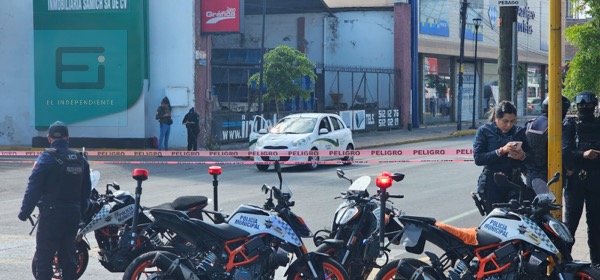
[30, 169, 209, 279]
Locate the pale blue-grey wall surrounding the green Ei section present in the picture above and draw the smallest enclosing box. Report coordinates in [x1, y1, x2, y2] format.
[0, 0, 195, 148]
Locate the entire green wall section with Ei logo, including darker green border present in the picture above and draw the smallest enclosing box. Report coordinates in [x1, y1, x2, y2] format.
[33, 0, 148, 129]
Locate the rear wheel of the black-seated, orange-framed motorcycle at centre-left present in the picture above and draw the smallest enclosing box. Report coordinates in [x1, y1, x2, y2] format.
[123, 251, 192, 280]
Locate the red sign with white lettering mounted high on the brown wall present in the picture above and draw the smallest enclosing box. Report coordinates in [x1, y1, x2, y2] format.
[201, 0, 242, 33]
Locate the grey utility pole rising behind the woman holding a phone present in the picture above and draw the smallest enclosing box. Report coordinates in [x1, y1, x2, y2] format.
[496, 6, 518, 101]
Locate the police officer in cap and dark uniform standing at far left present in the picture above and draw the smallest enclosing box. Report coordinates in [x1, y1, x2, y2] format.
[18, 121, 91, 280]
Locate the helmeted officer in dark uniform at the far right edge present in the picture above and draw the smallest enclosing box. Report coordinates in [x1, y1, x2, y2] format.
[564, 91, 600, 266]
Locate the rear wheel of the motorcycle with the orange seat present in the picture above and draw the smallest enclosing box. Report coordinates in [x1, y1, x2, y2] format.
[375, 258, 437, 280]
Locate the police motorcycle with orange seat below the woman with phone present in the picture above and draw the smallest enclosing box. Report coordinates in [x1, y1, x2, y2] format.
[375, 173, 600, 279]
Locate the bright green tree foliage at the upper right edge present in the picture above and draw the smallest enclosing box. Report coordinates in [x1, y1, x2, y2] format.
[563, 0, 600, 98]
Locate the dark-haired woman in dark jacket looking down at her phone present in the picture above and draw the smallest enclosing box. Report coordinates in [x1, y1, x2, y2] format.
[473, 101, 530, 213]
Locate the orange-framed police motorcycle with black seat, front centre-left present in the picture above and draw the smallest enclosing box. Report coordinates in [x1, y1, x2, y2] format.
[123, 161, 348, 279]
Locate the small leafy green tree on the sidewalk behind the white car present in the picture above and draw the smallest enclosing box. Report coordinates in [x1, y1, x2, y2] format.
[248, 45, 317, 113]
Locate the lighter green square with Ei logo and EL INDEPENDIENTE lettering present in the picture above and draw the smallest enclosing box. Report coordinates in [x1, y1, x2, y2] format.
[35, 30, 127, 126]
